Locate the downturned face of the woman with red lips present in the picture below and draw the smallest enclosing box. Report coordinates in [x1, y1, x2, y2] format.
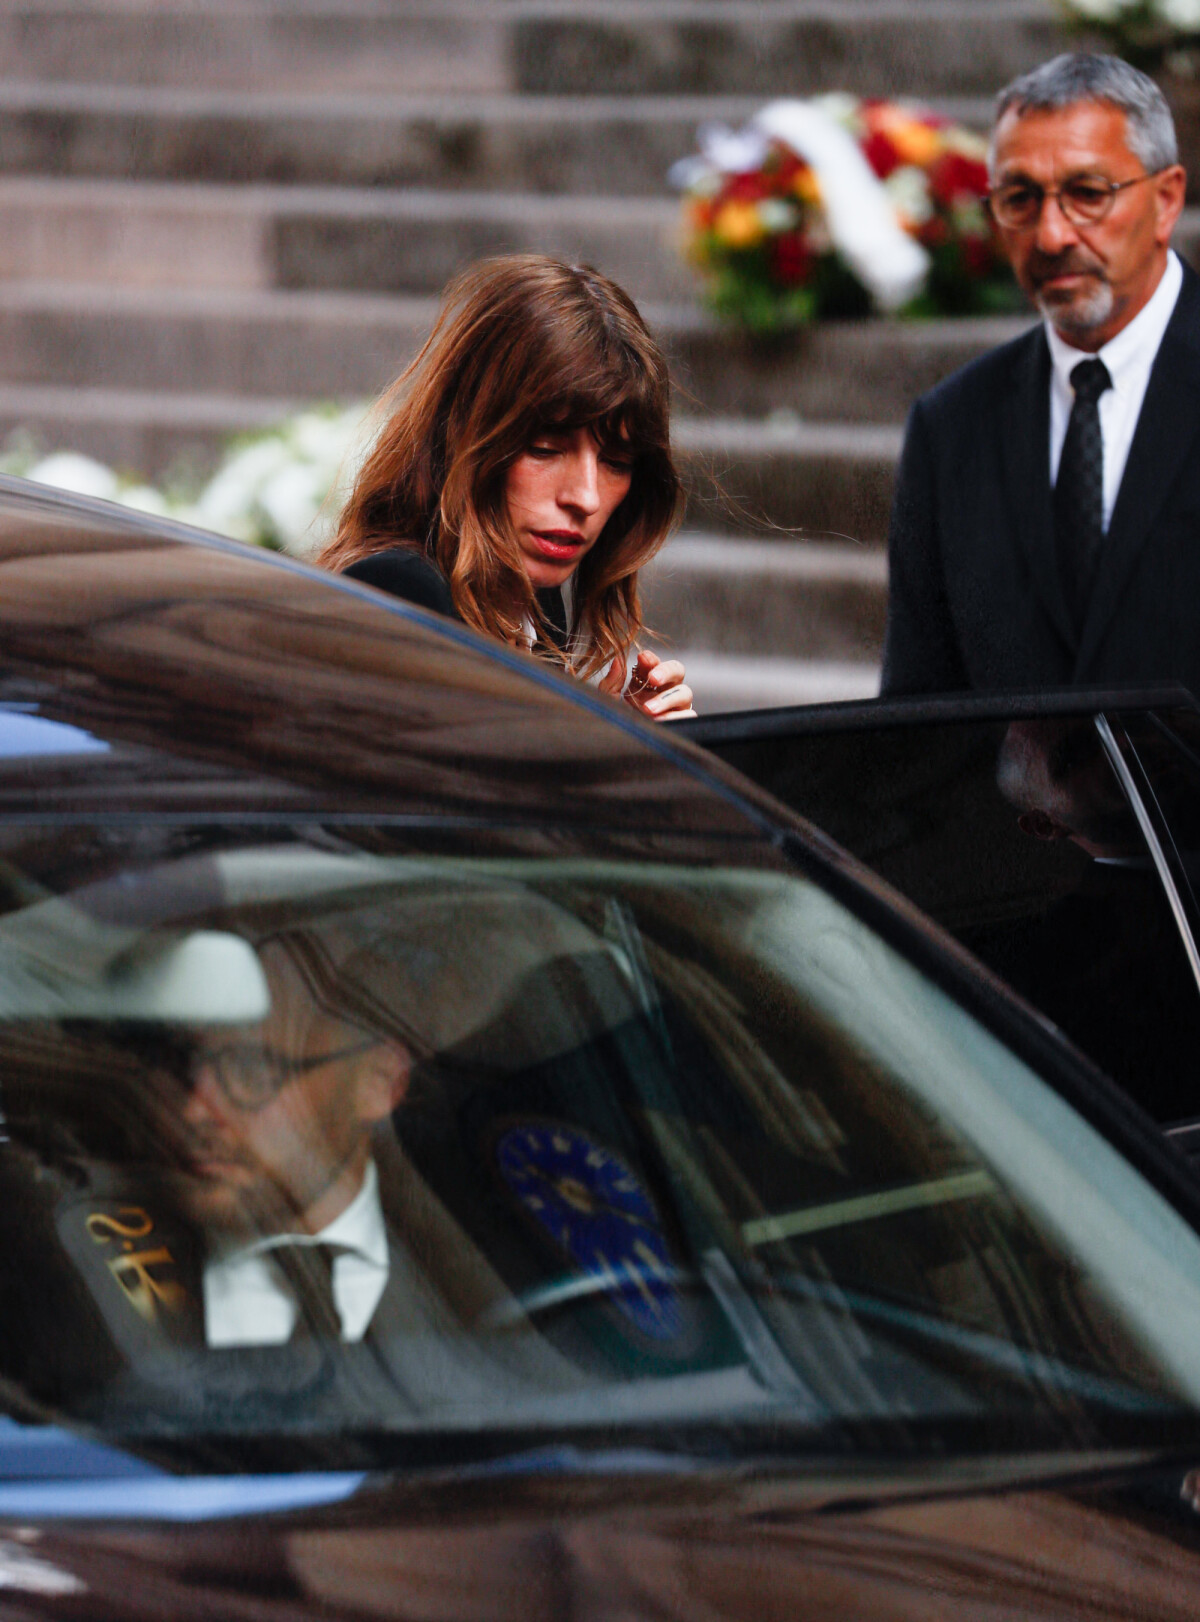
[504, 428, 632, 589]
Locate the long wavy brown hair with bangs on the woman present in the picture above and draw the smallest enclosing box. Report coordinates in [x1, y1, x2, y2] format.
[318, 253, 683, 675]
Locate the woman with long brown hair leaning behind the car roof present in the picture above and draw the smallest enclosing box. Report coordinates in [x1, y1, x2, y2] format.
[319, 255, 694, 720]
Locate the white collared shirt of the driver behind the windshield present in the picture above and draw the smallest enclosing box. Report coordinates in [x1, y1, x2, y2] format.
[204, 1161, 388, 1346]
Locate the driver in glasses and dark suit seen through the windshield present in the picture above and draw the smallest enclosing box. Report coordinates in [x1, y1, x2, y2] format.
[7, 928, 579, 1429]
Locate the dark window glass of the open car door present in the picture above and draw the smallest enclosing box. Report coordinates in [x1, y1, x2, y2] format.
[707, 717, 1200, 1122]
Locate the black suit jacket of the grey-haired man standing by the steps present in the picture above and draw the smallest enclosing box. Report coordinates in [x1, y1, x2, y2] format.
[882, 268, 1200, 694]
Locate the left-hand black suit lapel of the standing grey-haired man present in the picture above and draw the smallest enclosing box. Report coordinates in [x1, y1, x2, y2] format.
[1001, 328, 1075, 652]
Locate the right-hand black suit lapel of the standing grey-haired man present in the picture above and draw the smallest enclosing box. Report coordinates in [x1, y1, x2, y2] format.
[1074, 257, 1200, 681]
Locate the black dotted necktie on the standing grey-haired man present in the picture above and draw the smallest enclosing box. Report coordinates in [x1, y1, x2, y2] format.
[1054, 360, 1112, 629]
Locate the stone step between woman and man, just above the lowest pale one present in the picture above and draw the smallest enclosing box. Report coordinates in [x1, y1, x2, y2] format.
[642, 534, 887, 663]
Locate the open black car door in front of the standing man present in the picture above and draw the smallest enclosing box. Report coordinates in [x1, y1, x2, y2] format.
[683, 688, 1200, 1158]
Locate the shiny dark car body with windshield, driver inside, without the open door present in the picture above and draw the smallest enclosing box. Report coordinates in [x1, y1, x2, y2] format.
[0, 482, 1200, 1622]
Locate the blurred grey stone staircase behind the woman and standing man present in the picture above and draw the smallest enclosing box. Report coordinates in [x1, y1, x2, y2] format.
[0, 0, 1102, 712]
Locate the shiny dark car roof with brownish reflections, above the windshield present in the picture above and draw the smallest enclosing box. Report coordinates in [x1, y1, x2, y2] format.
[0, 478, 798, 837]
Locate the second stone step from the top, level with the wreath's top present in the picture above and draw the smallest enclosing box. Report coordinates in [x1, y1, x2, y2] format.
[0, 79, 991, 196]
